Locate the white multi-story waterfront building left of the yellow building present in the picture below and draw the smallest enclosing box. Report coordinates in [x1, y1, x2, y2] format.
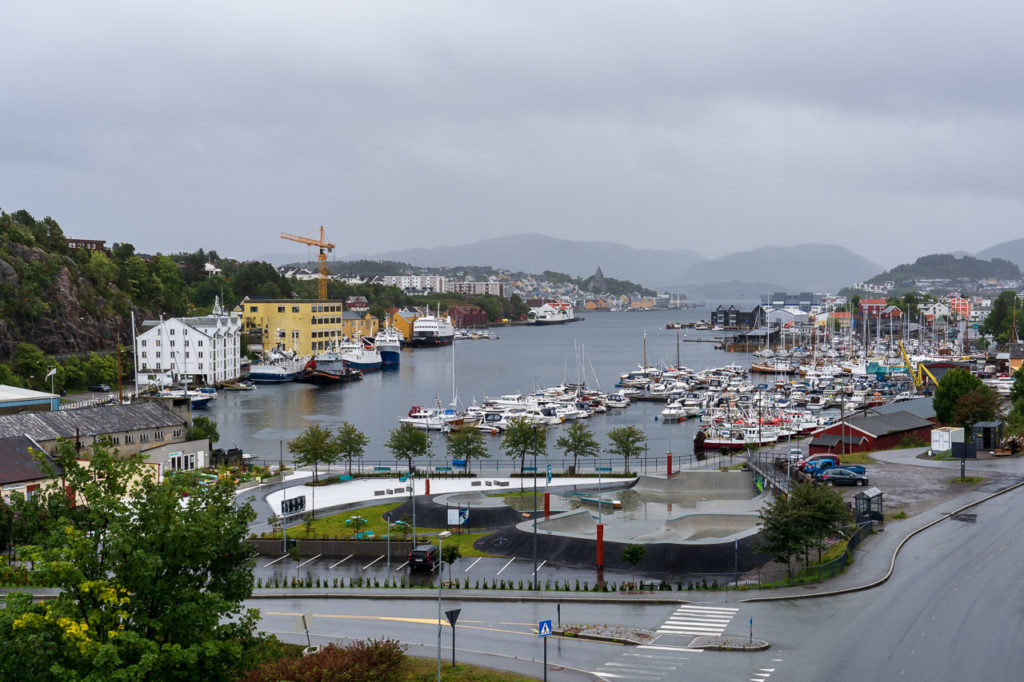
[135, 303, 242, 387]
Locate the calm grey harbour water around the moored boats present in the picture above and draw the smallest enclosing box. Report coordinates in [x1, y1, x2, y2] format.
[207, 307, 750, 467]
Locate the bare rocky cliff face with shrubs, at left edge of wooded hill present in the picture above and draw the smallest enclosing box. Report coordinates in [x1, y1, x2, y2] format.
[0, 244, 136, 358]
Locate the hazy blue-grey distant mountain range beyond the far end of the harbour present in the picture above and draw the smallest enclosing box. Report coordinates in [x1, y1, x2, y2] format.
[359, 235, 884, 295]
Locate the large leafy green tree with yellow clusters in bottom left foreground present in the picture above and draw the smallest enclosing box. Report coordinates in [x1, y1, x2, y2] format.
[0, 441, 258, 680]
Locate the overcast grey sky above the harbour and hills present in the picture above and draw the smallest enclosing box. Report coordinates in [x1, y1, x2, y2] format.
[0, 0, 1024, 265]
